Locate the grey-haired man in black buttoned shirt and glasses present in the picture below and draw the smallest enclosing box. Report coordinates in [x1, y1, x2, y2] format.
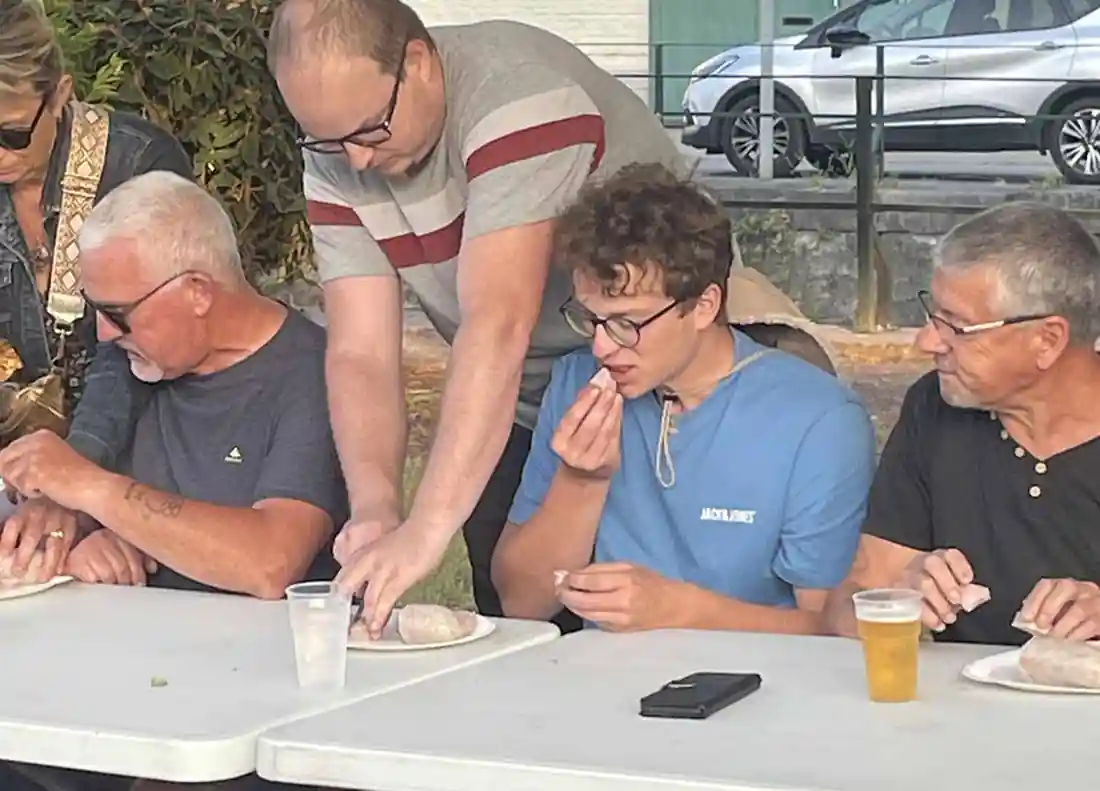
[829, 202, 1100, 645]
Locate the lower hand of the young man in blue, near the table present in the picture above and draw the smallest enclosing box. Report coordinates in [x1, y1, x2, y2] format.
[556, 563, 683, 631]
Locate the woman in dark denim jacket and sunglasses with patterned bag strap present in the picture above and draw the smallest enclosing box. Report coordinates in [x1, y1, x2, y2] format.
[0, 0, 193, 589]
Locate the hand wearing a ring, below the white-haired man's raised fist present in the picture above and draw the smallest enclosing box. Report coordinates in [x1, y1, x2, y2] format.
[0, 497, 79, 583]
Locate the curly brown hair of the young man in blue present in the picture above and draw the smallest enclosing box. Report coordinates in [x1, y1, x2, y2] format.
[553, 164, 734, 319]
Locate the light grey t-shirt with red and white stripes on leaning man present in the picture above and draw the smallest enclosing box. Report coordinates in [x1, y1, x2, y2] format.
[304, 20, 688, 428]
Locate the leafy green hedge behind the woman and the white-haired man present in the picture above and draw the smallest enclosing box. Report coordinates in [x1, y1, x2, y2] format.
[45, 0, 312, 286]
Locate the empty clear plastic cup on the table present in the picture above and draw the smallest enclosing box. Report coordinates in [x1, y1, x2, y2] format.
[286, 582, 351, 692]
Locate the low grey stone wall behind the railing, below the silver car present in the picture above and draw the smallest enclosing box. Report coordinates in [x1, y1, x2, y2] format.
[708, 178, 1100, 327]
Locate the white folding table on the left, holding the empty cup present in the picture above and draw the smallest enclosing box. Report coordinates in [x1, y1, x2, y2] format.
[0, 583, 559, 782]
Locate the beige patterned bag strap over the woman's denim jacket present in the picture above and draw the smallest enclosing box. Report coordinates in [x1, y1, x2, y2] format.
[46, 101, 110, 336]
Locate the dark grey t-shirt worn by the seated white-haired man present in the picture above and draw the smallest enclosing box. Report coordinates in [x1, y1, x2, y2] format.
[122, 310, 349, 591]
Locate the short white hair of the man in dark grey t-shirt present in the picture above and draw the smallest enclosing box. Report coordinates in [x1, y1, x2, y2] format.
[77, 171, 244, 287]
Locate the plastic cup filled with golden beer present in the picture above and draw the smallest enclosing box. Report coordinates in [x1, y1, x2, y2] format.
[851, 589, 921, 703]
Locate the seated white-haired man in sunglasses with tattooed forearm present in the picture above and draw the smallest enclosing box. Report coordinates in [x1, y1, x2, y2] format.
[0, 172, 347, 598]
